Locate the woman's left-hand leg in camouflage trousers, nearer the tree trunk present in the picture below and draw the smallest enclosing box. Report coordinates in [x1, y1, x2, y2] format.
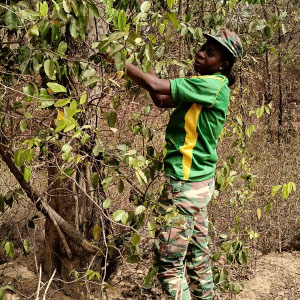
[153, 180, 193, 300]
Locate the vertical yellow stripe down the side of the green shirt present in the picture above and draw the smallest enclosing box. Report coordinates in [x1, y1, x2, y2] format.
[180, 103, 202, 180]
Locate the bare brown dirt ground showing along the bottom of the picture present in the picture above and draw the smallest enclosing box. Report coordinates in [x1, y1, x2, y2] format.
[0, 252, 300, 300]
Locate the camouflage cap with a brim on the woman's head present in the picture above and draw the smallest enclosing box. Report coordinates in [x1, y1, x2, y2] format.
[203, 28, 243, 57]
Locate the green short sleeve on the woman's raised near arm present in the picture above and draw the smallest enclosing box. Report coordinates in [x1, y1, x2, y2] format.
[170, 75, 228, 107]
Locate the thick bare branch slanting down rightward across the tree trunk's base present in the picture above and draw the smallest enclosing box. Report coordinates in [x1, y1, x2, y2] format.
[0, 143, 100, 254]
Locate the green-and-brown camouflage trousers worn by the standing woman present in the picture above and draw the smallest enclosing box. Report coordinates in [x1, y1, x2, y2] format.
[153, 178, 214, 300]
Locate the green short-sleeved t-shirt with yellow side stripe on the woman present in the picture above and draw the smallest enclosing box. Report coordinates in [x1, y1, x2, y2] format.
[164, 74, 230, 181]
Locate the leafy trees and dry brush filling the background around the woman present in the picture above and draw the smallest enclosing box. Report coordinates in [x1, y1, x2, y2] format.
[0, 0, 300, 299]
